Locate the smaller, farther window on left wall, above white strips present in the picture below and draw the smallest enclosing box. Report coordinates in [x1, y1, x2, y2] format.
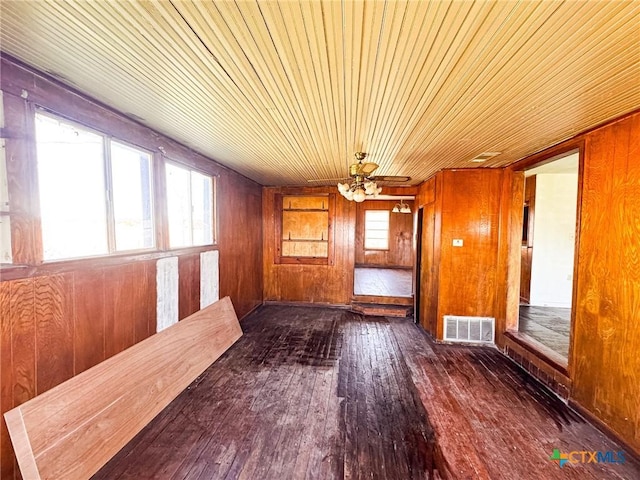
[166, 162, 215, 248]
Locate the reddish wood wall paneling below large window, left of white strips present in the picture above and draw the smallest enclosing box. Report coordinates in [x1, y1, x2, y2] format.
[0, 261, 156, 479]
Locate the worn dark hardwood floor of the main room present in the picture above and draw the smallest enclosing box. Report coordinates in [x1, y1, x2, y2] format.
[95, 305, 640, 480]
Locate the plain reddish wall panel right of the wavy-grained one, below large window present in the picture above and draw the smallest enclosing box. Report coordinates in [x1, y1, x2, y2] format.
[74, 269, 106, 375]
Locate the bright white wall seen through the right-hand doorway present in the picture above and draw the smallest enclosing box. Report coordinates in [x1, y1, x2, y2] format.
[529, 173, 578, 308]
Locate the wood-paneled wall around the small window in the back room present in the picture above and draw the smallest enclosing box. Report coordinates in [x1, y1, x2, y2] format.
[356, 199, 415, 267]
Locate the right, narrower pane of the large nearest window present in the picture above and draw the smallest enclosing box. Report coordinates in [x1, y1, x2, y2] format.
[111, 142, 155, 250]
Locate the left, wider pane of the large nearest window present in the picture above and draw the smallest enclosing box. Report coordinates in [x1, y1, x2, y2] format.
[36, 114, 108, 260]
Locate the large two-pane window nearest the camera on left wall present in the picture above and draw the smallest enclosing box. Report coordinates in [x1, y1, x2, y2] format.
[35, 112, 155, 261]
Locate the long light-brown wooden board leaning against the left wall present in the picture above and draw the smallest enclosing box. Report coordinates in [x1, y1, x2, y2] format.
[5, 297, 242, 480]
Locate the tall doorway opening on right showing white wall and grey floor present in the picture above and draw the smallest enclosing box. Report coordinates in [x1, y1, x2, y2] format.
[518, 150, 580, 366]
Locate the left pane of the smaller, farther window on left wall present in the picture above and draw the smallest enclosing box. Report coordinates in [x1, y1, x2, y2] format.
[166, 163, 192, 247]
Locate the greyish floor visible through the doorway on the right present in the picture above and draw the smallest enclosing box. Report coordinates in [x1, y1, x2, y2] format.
[518, 305, 571, 358]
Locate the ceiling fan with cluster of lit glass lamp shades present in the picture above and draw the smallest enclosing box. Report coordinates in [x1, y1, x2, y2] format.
[308, 152, 411, 203]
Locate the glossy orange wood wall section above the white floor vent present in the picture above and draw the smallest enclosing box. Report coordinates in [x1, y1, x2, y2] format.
[418, 169, 511, 339]
